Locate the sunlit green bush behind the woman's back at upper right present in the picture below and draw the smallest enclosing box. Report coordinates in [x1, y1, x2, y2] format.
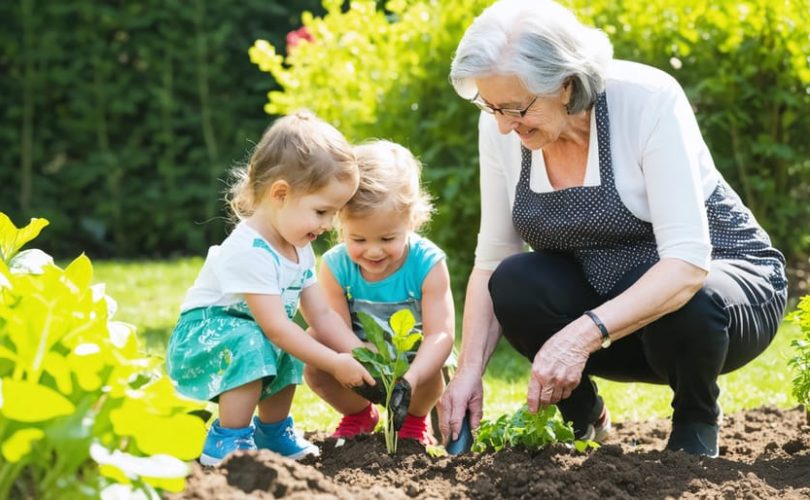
[571, 0, 810, 266]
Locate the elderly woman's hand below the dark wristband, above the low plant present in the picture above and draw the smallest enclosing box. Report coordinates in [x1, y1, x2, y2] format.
[526, 325, 592, 413]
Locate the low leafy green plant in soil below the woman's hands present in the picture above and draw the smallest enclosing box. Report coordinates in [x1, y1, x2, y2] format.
[472, 405, 599, 453]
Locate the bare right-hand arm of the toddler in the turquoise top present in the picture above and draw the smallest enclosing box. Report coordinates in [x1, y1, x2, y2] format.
[404, 260, 455, 386]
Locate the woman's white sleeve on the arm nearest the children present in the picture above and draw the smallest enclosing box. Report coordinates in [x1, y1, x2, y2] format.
[475, 112, 523, 270]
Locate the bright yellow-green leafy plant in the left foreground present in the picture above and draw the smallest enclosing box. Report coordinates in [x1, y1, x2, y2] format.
[0, 213, 205, 499]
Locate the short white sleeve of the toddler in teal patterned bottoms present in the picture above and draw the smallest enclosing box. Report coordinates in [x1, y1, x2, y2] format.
[214, 247, 281, 295]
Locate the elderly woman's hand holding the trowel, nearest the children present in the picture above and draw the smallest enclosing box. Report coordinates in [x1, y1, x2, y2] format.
[438, 370, 484, 442]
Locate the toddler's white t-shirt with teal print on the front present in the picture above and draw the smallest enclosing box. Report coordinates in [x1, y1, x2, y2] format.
[180, 222, 316, 318]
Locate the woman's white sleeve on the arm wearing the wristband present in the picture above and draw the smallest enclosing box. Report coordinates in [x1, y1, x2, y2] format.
[641, 79, 712, 270]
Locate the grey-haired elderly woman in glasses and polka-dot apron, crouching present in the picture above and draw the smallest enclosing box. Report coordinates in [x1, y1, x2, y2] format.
[440, 0, 787, 457]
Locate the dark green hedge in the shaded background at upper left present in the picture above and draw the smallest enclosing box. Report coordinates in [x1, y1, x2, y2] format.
[0, 0, 326, 258]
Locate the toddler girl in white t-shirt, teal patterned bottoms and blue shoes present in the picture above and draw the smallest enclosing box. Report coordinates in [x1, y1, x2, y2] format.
[167, 111, 374, 465]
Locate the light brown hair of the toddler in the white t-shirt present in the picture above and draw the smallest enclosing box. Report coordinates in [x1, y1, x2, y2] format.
[227, 110, 358, 218]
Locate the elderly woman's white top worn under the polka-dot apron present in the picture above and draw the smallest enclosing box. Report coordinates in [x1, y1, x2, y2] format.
[475, 60, 721, 270]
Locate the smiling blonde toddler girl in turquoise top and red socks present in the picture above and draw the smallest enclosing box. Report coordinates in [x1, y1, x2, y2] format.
[305, 141, 455, 444]
